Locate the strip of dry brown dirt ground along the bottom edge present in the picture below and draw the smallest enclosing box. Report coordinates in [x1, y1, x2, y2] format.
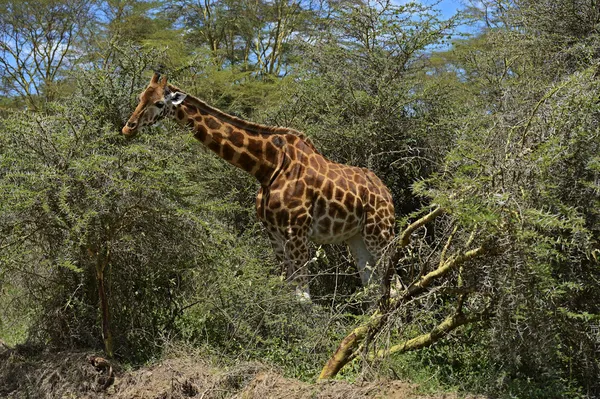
[0, 350, 478, 399]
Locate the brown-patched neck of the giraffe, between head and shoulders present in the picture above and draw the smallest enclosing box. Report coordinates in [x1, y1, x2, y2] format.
[164, 86, 289, 184]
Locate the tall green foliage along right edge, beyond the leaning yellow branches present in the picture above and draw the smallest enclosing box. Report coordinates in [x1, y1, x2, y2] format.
[400, 3, 600, 397]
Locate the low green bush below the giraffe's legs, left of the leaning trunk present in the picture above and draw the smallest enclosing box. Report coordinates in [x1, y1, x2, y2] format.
[177, 232, 339, 380]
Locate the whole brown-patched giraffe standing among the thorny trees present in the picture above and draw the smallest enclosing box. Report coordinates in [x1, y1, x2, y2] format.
[122, 73, 394, 299]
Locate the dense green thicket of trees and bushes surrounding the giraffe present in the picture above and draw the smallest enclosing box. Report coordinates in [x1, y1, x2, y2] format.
[0, 0, 600, 398]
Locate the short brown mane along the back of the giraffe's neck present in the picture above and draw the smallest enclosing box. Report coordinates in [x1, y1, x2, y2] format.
[168, 83, 320, 153]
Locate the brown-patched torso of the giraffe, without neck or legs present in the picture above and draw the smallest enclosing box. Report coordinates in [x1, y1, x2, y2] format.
[257, 135, 394, 244]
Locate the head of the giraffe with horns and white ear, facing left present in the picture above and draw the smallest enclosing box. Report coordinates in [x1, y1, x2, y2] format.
[121, 73, 186, 136]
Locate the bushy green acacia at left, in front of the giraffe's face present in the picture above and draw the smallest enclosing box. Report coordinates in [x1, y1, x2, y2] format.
[0, 49, 213, 357]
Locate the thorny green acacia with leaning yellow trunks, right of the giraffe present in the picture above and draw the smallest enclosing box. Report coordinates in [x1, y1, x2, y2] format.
[320, 68, 600, 397]
